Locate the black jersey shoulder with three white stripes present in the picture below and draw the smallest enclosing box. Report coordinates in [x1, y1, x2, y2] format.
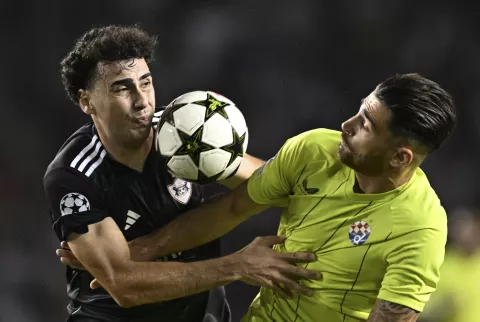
[45, 123, 107, 182]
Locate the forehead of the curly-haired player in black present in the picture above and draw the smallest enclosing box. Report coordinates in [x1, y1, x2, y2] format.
[97, 58, 150, 82]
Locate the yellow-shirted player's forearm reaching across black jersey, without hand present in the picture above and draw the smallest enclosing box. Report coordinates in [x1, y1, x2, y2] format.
[129, 183, 266, 261]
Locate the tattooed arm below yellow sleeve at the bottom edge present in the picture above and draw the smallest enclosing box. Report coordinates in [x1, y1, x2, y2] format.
[367, 300, 419, 322]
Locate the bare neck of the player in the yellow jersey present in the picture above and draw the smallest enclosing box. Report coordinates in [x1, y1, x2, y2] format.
[354, 169, 415, 194]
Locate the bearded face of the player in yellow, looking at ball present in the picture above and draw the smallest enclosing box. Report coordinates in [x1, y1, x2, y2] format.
[338, 92, 396, 176]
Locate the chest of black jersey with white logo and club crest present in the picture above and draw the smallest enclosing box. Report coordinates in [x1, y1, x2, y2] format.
[95, 160, 203, 241]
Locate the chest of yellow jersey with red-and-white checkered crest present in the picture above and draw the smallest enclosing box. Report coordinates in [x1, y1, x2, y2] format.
[279, 169, 392, 276]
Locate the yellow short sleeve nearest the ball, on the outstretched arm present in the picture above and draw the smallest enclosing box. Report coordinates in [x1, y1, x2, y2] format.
[248, 136, 304, 205]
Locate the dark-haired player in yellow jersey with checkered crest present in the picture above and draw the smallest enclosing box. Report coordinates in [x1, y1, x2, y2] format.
[58, 74, 456, 322]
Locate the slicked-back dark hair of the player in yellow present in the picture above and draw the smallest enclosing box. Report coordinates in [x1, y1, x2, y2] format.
[375, 74, 457, 153]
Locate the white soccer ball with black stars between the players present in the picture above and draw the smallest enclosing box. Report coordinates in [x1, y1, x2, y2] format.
[155, 91, 248, 183]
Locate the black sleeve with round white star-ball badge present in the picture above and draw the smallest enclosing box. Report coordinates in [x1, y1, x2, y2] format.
[43, 168, 108, 240]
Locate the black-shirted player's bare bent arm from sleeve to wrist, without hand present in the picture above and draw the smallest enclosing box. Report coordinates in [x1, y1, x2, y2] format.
[68, 218, 240, 307]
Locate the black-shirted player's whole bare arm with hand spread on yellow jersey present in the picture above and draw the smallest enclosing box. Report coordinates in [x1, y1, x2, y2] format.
[68, 217, 320, 307]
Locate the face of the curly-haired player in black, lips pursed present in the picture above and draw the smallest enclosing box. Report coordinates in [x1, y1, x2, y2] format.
[80, 59, 155, 148]
